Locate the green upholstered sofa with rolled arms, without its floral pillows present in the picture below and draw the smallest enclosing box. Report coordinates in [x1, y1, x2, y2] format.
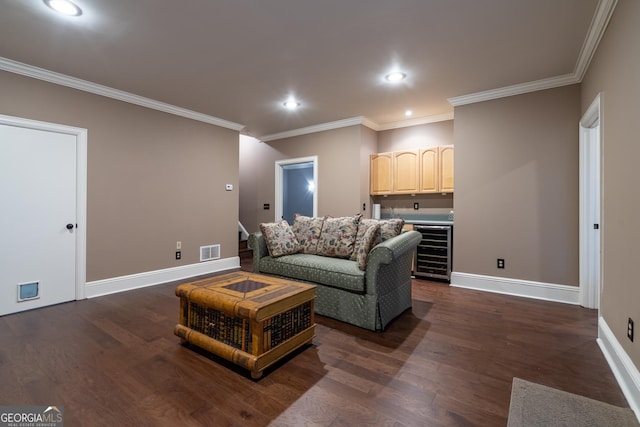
[249, 231, 422, 331]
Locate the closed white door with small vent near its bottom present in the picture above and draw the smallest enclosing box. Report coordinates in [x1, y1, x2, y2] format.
[0, 119, 78, 315]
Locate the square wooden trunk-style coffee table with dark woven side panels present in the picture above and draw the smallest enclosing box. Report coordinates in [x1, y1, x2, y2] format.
[174, 272, 315, 379]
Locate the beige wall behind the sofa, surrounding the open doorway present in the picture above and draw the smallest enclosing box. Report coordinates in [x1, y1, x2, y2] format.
[240, 125, 371, 232]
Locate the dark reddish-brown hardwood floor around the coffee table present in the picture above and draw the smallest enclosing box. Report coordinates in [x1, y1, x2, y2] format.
[0, 267, 628, 427]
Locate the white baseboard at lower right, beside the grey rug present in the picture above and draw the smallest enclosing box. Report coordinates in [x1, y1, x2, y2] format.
[597, 317, 640, 421]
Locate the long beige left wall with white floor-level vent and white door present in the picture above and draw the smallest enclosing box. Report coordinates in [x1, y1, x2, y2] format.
[0, 72, 238, 281]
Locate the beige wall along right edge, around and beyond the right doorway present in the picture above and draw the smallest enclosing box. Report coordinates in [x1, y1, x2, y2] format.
[582, 0, 640, 368]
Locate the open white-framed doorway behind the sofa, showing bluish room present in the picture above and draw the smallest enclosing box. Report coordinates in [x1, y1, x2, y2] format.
[275, 156, 318, 224]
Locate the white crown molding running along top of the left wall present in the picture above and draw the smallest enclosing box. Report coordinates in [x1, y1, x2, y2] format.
[0, 57, 244, 131]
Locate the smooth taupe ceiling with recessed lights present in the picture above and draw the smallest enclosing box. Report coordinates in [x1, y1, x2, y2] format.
[0, 0, 611, 140]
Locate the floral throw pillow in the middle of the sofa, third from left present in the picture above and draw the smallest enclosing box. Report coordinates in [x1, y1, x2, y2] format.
[317, 214, 362, 258]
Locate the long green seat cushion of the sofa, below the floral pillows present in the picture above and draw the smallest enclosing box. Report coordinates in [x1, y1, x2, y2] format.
[260, 254, 365, 292]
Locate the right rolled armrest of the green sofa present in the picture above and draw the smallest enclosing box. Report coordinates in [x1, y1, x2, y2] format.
[365, 230, 422, 295]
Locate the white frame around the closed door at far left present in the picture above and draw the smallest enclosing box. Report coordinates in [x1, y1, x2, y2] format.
[0, 114, 87, 300]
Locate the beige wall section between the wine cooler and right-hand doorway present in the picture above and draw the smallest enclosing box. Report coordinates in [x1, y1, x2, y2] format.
[453, 85, 580, 286]
